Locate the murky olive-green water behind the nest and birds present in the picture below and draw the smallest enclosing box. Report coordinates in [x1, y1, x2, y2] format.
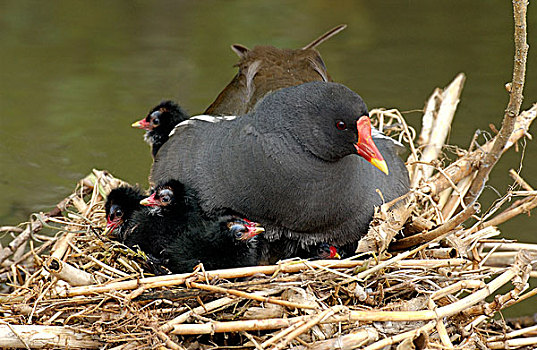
[0, 0, 537, 313]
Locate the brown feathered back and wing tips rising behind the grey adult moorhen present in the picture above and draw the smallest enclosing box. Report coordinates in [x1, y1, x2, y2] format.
[204, 25, 347, 115]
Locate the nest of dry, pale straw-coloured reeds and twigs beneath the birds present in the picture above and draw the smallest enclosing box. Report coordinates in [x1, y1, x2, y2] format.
[0, 74, 537, 349]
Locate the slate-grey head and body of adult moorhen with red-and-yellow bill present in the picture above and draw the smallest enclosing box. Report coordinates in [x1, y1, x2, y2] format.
[151, 82, 409, 261]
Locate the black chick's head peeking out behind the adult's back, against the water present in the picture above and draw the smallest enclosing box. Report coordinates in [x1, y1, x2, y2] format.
[131, 101, 190, 158]
